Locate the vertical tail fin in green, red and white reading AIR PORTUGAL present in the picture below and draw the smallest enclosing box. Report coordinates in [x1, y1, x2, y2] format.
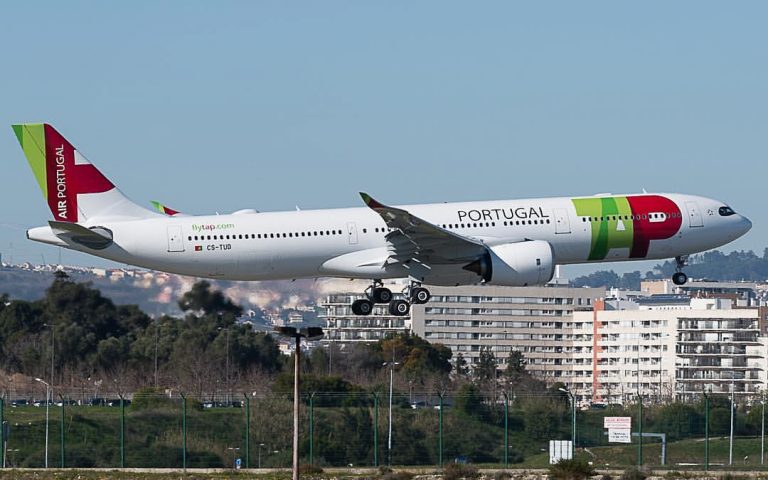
[13, 123, 158, 223]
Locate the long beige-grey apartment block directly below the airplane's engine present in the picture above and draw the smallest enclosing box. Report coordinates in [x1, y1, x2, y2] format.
[411, 286, 605, 404]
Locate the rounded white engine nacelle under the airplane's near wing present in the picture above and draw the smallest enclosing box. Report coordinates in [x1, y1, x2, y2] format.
[464, 240, 555, 287]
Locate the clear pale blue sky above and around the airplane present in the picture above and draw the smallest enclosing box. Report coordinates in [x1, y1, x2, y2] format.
[0, 1, 768, 278]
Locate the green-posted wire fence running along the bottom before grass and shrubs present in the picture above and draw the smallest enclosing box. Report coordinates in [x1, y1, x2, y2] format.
[0, 388, 766, 470]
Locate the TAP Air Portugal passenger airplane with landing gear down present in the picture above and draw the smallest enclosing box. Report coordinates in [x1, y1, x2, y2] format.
[13, 123, 752, 316]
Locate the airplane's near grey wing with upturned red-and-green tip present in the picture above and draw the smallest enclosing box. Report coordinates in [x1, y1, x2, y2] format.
[360, 192, 487, 268]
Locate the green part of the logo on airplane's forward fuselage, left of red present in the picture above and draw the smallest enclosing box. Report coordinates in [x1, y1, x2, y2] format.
[573, 197, 634, 260]
